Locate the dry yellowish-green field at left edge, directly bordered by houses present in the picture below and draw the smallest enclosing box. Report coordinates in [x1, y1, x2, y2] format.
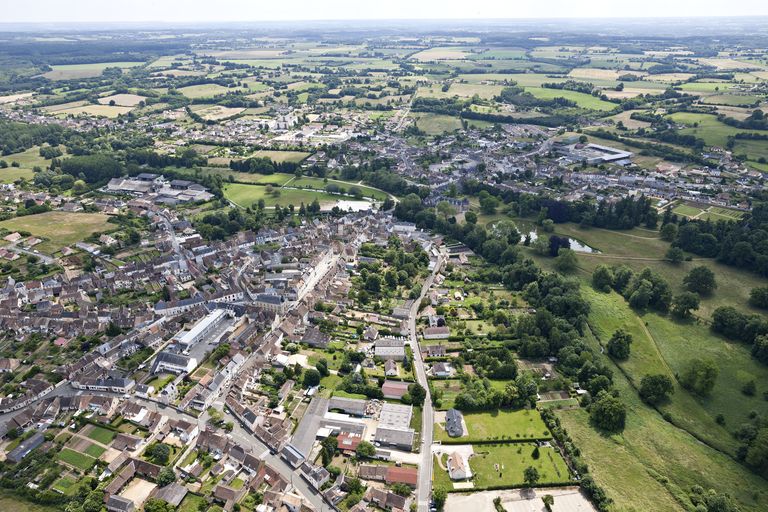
[0, 211, 115, 254]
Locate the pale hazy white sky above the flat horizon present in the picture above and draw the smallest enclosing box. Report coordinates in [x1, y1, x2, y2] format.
[0, 0, 768, 22]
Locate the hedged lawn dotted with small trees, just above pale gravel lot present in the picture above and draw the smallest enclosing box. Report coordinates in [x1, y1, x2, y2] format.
[469, 443, 570, 489]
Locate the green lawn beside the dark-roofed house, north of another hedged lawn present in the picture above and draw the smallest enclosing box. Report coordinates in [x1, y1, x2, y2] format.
[435, 409, 551, 442]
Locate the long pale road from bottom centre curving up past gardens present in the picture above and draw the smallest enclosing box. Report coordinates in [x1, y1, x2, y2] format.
[408, 254, 443, 512]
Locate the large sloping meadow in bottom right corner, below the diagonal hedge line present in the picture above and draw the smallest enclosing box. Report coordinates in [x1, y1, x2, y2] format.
[556, 324, 768, 512]
